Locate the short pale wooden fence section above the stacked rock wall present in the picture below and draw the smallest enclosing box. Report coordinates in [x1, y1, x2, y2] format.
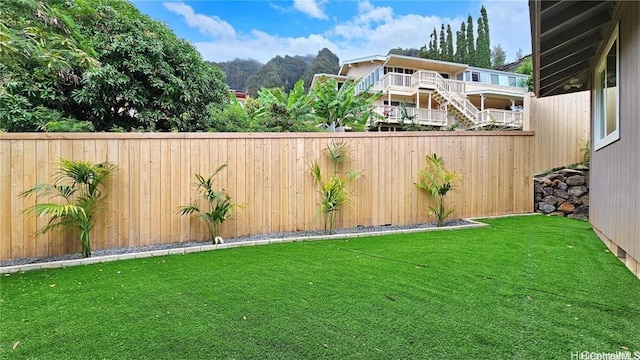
[524, 91, 591, 172]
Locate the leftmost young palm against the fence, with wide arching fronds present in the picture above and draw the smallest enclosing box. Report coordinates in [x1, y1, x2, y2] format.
[20, 159, 116, 257]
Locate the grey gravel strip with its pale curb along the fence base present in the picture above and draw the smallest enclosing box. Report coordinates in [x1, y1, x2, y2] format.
[0, 219, 489, 276]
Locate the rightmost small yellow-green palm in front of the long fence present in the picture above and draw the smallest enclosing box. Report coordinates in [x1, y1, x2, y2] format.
[413, 153, 462, 227]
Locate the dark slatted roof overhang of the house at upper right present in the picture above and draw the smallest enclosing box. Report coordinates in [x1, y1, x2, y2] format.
[529, 0, 615, 97]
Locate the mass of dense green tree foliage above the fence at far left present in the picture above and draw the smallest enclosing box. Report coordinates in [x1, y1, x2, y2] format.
[0, 0, 228, 131]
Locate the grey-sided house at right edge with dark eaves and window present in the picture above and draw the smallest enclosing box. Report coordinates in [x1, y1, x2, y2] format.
[529, 0, 640, 277]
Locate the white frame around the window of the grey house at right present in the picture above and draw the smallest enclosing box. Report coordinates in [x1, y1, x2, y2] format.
[592, 25, 620, 151]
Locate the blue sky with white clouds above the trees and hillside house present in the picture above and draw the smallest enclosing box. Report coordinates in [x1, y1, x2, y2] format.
[132, 0, 531, 63]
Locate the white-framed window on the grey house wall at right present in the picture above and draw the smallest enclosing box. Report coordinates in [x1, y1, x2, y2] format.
[593, 26, 620, 150]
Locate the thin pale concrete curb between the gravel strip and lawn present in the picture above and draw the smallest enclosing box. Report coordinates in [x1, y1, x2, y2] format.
[0, 217, 489, 275]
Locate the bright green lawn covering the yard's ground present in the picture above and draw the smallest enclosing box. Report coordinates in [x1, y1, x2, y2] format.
[0, 216, 640, 359]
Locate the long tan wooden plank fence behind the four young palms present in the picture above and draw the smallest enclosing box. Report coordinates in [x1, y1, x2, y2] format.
[0, 132, 534, 259]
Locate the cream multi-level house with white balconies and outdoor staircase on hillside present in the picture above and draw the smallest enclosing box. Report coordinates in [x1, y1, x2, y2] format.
[312, 54, 527, 131]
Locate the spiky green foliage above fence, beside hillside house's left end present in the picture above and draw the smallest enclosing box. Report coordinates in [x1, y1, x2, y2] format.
[310, 78, 382, 130]
